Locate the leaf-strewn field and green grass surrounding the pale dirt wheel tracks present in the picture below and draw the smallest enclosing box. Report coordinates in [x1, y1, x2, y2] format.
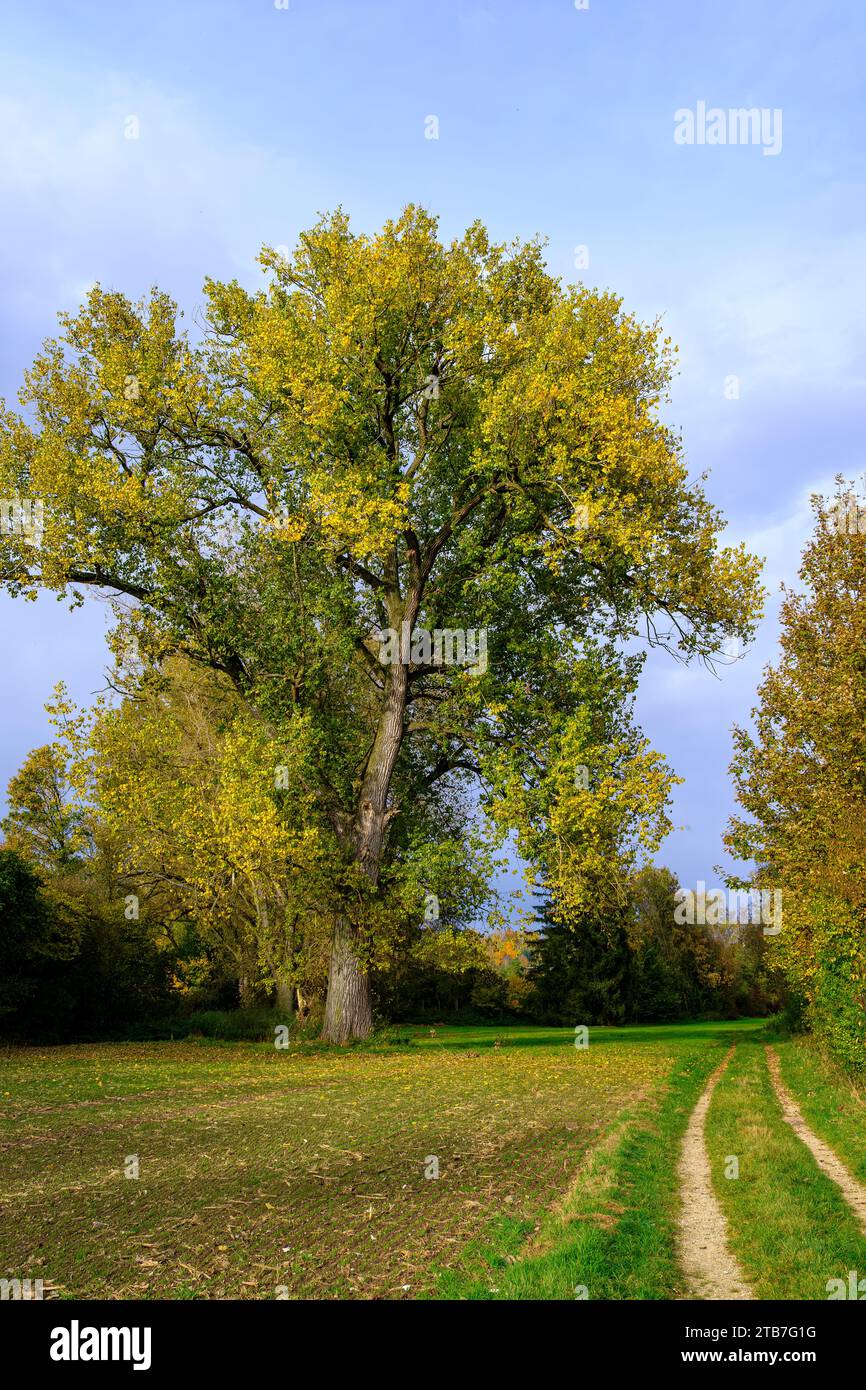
[0, 1020, 866, 1298]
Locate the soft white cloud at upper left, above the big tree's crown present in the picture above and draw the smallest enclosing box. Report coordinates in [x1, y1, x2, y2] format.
[0, 75, 297, 321]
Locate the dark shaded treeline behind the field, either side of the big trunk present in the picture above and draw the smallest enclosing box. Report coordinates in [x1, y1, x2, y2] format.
[0, 806, 783, 1043]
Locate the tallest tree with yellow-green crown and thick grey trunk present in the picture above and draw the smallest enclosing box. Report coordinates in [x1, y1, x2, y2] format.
[0, 207, 759, 1041]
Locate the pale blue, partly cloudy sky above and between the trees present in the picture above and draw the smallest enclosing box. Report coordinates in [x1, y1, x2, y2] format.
[0, 0, 866, 884]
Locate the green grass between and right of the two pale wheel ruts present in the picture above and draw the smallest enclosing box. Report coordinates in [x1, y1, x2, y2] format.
[706, 1038, 866, 1298]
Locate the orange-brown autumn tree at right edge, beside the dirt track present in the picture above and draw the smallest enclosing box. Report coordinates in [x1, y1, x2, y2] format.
[726, 480, 866, 1068]
